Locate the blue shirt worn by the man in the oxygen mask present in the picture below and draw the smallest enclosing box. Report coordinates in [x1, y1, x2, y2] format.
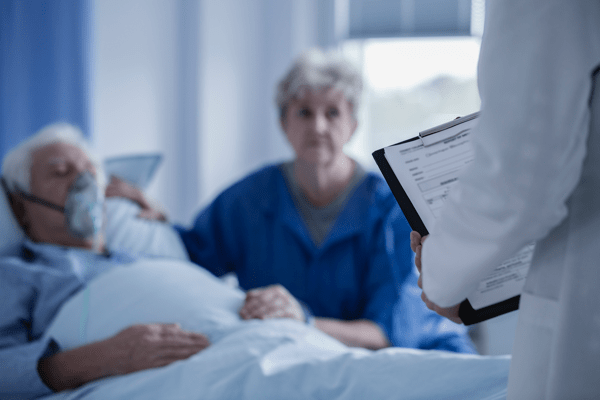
[0, 241, 133, 399]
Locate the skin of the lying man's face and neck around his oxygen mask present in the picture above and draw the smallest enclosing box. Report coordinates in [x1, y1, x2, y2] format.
[22, 143, 101, 248]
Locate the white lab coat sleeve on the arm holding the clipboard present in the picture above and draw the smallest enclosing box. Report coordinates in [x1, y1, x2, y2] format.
[422, 0, 597, 307]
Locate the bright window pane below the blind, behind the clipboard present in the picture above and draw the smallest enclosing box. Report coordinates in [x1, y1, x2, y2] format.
[342, 36, 480, 169]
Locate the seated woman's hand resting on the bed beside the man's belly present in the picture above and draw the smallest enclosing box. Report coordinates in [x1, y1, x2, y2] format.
[240, 285, 306, 322]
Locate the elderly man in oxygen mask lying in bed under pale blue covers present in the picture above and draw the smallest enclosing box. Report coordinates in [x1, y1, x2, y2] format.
[0, 125, 509, 400]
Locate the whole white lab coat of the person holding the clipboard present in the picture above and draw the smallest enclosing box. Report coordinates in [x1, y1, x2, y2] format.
[422, 0, 600, 400]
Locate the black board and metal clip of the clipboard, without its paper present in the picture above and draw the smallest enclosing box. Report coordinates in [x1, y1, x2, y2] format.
[372, 113, 521, 325]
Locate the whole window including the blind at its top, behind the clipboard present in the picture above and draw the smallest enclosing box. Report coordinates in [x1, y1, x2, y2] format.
[341, 0, 485, 170]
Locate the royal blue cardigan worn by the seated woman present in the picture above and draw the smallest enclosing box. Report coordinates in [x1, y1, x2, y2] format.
[176, 165, 475, 353]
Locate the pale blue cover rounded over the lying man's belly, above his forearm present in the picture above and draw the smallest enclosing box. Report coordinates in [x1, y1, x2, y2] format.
[45, 259, 245, 350]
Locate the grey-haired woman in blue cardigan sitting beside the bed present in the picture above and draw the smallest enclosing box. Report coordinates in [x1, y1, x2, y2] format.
[177, 50, 473, 352]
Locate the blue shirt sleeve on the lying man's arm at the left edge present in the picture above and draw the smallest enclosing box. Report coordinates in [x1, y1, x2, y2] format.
[0, 274, 58, 398]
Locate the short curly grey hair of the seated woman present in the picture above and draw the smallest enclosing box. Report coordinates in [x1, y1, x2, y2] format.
[275, 48, 363, 120]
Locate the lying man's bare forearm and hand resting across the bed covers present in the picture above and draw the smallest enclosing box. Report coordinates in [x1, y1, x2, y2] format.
[38, 324, 210, 392]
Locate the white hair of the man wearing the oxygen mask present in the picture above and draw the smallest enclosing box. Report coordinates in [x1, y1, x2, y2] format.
[2, 122, 105, 193]
